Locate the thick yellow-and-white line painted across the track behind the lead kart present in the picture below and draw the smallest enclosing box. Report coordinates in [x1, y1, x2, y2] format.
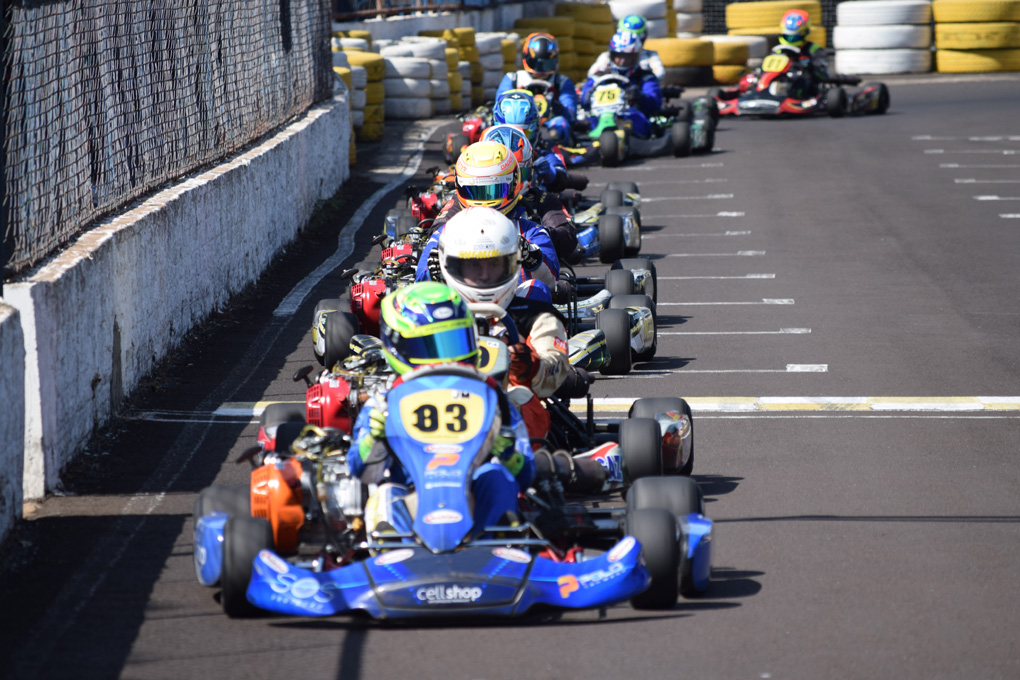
[124, 395, 1020, 425]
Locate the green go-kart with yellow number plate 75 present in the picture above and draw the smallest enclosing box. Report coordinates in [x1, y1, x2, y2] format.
[578, 73, 693, 167]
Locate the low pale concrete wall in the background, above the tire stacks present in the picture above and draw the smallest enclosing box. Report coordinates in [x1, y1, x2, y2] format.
[333, 2, 554, 40]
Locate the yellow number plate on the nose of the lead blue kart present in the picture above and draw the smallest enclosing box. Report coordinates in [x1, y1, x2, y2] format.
[400, 389, 486, 443]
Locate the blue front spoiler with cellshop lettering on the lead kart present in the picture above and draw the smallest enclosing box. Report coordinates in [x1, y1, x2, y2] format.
[248, 536, 651, 619]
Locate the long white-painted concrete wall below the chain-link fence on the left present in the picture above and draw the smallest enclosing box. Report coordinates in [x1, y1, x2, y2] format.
[4, 94, 350, 499]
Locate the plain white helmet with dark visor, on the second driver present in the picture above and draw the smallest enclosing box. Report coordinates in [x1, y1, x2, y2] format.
[438, 208, 520, 308]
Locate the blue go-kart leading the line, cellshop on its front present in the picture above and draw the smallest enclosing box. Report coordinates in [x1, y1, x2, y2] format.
[194, 366, 712, 618]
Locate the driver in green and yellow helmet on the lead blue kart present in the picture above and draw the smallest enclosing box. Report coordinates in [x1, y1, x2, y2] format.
[348, 281, 534, 532]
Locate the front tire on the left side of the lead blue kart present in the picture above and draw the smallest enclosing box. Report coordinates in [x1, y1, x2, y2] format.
[219, 516, 272, 619]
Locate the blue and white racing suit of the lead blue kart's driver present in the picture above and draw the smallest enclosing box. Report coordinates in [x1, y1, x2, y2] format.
[348, 374, 534, 532]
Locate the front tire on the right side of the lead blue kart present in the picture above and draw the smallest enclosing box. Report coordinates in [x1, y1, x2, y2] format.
[627, 508, 680, 610]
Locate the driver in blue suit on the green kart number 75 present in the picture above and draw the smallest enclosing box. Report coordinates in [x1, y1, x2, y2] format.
[580, 32, 662, 139]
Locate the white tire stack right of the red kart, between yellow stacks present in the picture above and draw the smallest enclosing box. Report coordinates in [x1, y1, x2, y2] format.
[832, 0, 931, 74]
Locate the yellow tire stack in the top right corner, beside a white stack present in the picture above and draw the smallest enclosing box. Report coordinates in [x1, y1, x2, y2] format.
[931, 0, 1020, 73]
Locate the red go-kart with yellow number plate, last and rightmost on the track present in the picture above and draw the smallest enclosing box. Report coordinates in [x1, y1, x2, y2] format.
[709, 47, 889, 118]
